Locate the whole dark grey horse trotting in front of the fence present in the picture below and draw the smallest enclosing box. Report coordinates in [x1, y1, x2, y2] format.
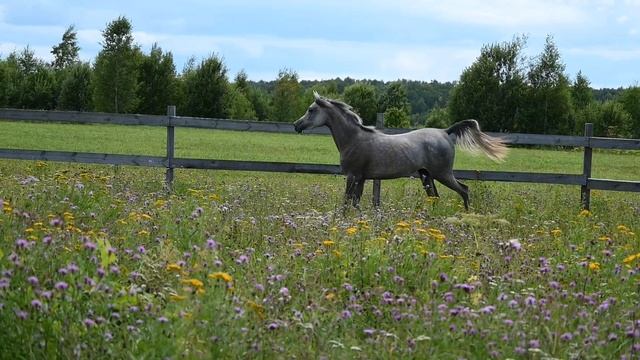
[294, 92, 508, 210]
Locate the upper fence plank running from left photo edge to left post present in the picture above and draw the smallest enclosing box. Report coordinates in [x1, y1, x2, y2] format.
[0, 108, 169, 126]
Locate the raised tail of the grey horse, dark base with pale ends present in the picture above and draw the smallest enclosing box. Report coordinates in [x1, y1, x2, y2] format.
[445, 119, 509, 162]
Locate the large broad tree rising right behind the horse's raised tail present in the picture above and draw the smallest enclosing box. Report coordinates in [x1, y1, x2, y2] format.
[448, 37, 526, 131]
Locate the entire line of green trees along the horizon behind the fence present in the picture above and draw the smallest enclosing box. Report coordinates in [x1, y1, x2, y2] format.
[0, 17, 640, 137]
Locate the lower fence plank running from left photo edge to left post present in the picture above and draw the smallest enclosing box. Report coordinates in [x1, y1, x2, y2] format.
[0, 149, 166, 167]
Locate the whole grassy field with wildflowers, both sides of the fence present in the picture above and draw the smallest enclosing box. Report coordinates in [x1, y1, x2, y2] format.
[0, 122, 640, 359]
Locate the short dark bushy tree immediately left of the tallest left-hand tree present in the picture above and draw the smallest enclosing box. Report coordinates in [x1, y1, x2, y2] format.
[57, 63, 93, 111]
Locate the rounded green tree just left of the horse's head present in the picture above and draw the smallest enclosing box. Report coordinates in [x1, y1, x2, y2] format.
[271, 69, 308, 122]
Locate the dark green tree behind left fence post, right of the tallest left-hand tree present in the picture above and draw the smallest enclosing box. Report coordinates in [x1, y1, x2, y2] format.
[138, 44, 177, 114]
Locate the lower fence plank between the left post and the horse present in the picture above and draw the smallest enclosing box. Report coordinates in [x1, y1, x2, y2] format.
[173, 158, 342, 175]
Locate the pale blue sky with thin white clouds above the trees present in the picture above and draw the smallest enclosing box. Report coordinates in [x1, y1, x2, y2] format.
[0, 0, 640, 88]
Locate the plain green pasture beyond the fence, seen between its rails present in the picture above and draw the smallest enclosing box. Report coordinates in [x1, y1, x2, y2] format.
[0, 121, 640, 180]
